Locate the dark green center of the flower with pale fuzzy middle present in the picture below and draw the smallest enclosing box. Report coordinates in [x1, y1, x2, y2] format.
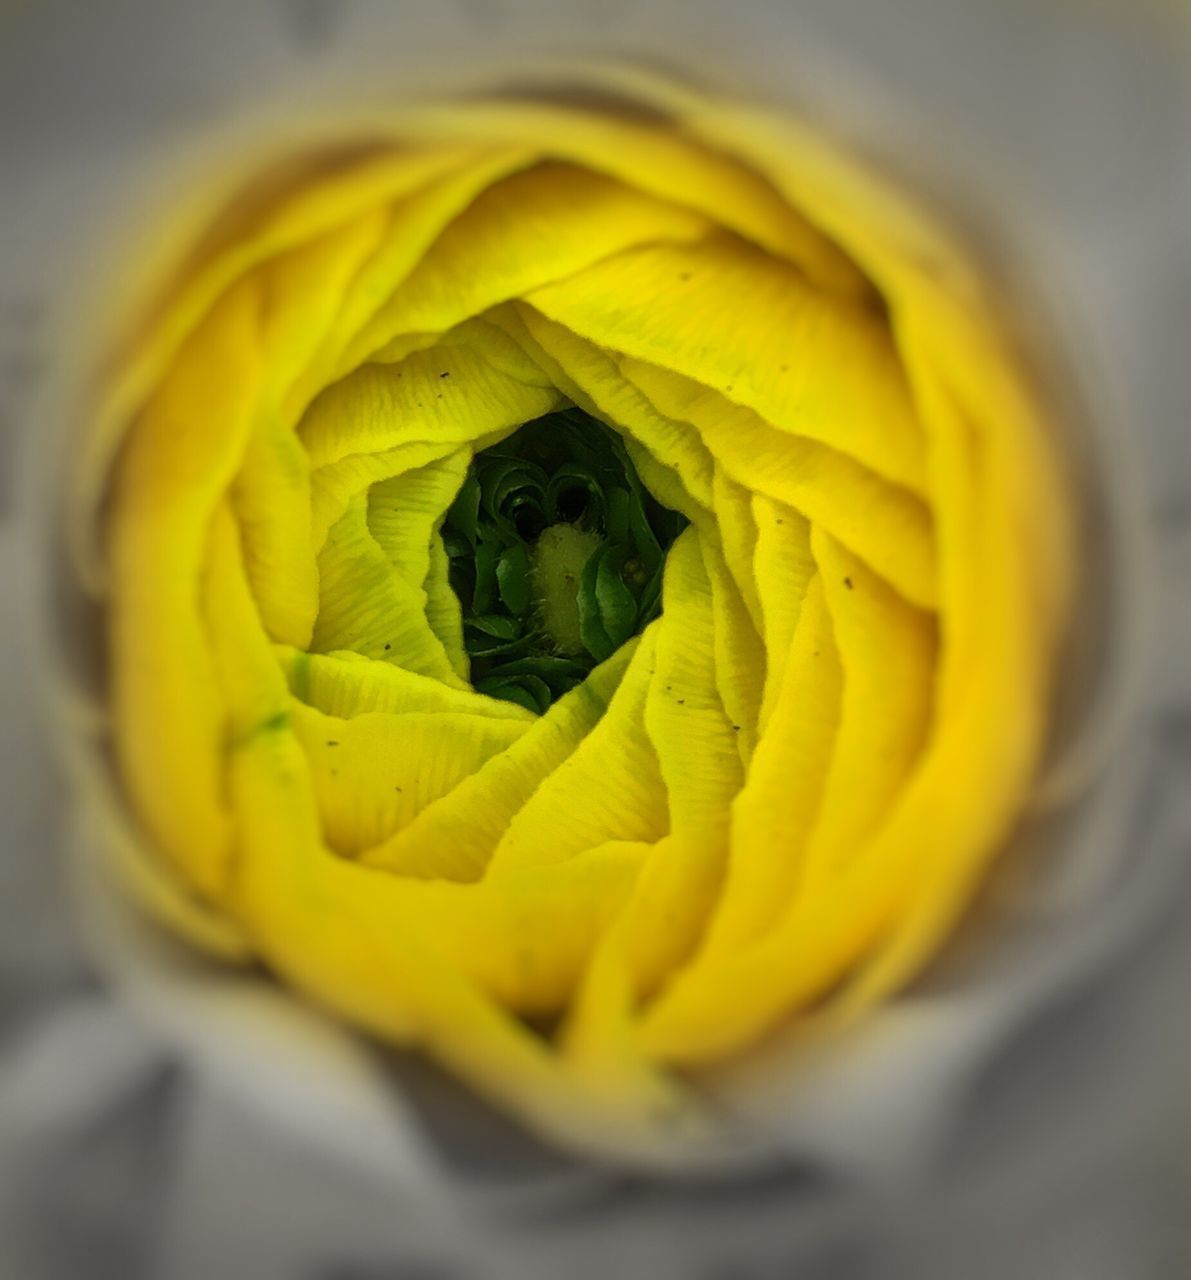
[442, 408, 686, 712]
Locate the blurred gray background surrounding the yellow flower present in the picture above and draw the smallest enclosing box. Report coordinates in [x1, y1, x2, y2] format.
[0, 0, 1191, 1280]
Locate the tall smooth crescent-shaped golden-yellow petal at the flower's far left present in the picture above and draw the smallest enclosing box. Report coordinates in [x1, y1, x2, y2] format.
[110, 280, 261, 892]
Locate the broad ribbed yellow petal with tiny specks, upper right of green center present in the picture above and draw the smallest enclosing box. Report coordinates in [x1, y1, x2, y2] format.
[525, 234, 925, 493]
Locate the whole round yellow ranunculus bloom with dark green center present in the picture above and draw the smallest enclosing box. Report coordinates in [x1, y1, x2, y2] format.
[74, 72, 1071, 1162]
